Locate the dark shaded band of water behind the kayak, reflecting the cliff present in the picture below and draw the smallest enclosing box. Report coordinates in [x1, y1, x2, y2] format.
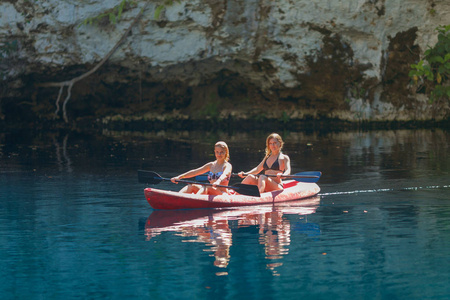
[0, 129, 450, 191]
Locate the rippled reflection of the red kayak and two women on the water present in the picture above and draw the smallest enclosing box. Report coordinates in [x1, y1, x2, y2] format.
[145, 196, 320, 275]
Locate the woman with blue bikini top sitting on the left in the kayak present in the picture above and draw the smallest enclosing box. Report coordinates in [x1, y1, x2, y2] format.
[171, 141, 233, 195]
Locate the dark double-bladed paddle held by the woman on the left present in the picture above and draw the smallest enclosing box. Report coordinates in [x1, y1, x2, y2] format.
[138, 170, 261, 197]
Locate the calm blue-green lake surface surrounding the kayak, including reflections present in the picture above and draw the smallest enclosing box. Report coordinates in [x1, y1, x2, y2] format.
[0, 129, 450, 299]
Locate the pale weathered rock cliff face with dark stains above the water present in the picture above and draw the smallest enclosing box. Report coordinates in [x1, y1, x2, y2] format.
[0, 0, 450, 121]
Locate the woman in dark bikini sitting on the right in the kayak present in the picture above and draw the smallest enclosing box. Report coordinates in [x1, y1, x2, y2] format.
[239, 133, 291, 193]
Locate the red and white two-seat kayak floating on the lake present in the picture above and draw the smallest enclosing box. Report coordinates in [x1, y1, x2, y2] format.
[144, 180, 320, 209]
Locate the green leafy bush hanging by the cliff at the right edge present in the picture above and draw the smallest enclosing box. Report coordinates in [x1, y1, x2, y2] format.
[409, 25, 450, 101]
